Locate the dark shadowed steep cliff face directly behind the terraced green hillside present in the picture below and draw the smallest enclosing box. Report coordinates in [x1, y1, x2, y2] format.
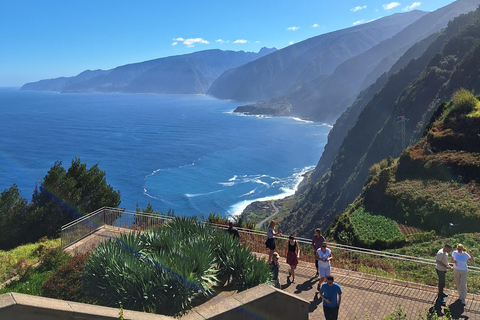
[282, 4, 480, 234]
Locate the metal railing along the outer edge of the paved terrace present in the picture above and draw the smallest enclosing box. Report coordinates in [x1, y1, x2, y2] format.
[61, 207, 480, 295]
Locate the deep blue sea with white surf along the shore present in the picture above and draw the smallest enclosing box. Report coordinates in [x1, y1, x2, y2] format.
[0, 88, 331, 216]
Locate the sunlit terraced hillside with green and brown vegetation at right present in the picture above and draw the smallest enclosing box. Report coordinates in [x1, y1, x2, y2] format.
[331, 89, 480, 246]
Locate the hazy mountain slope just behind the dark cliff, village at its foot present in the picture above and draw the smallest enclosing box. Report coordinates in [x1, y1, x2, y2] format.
[234, 0, 480, 123]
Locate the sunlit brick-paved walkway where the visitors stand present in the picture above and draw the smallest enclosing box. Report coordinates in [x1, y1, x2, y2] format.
[67, 228, 480, 320]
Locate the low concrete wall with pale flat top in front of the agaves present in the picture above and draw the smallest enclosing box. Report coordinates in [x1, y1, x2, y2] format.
[0, 285, 309, 320]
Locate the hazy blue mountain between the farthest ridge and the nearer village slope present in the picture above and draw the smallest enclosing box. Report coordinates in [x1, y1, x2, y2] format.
[207, 11, 426, 101]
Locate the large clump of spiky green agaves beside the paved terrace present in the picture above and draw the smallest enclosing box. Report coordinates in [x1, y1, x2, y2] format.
[83, 218, 271, 315]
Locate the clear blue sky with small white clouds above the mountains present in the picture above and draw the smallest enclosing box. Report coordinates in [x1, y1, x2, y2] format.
[0, 0, 454, 87]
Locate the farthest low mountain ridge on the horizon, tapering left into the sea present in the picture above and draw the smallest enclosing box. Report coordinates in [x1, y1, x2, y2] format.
[22, 48, 276, 94]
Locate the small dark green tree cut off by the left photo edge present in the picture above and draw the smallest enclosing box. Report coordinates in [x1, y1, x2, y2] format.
[0, 184, 27, 250]
